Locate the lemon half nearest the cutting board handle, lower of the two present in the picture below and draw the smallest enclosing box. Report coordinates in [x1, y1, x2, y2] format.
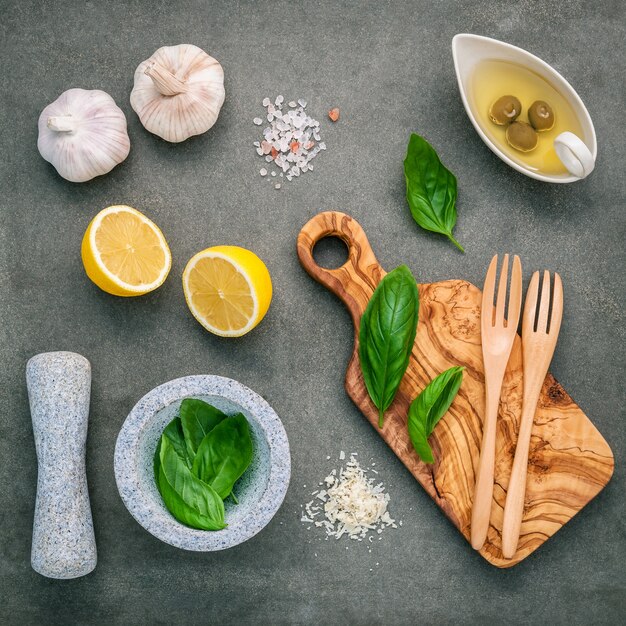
[183, 246, 272, 337]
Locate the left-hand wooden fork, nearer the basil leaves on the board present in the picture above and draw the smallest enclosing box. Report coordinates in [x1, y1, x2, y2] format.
[470, 254, 522, 550]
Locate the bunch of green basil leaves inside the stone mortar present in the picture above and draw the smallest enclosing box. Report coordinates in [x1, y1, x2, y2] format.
[154, 398, 253, 530]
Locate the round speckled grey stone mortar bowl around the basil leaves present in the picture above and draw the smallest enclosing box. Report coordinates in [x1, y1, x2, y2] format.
[115, 376, 291, 552]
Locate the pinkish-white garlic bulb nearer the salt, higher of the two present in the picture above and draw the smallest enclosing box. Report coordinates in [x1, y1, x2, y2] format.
[130, 44, 225, 143]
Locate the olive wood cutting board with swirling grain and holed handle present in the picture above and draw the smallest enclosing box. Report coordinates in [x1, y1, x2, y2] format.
[297, 212, 614, 567]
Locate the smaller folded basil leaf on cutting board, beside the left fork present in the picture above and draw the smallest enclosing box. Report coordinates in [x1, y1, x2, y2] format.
[408, 366, 465, 463]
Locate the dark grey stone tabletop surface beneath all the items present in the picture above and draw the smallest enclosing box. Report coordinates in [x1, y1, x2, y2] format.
[0, 0, 626, 624]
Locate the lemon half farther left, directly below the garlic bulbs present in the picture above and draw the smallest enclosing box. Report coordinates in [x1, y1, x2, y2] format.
[81, 205, 172, 297]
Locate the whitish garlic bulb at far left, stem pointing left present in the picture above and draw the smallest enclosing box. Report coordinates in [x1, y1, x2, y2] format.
[37, 89, 130, 183]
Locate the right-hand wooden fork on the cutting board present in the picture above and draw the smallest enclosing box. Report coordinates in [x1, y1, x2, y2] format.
[502, 271, 563, 559]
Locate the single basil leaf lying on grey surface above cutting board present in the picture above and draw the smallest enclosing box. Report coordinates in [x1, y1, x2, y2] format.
[404, 133, 465, 252]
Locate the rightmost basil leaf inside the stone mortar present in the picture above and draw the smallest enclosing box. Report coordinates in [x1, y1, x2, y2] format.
[192, 413, 252, 498]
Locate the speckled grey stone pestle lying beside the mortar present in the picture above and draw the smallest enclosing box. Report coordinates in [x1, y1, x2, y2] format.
[26, 352, 97, 578]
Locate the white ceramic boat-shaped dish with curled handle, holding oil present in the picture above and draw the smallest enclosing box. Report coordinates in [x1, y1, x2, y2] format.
[452, 34, 598, 183]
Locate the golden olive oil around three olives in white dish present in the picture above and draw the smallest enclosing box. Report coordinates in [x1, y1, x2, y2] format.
[467, 59, 584, 177]
